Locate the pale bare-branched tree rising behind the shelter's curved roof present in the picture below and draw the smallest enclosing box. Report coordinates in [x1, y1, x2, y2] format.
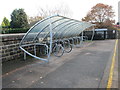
[28, 4, 72, 27]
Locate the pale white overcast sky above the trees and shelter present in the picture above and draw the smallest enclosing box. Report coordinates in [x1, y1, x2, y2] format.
[0, 0, 119, 24]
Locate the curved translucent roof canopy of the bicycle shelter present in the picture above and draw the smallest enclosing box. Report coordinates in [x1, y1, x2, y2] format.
[20, 15, 94, 62]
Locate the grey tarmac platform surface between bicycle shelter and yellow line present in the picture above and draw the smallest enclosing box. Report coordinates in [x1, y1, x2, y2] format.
[2, 40, 115, 88]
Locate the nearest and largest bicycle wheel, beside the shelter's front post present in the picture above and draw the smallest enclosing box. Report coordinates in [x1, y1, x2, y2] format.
[53, 45, 64, 57]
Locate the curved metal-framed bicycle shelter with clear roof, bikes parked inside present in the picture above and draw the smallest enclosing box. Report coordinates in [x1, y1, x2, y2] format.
[20, 15, 94, 62]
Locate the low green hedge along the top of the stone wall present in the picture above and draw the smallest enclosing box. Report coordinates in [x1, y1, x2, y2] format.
[1, 28, 29, 34]
